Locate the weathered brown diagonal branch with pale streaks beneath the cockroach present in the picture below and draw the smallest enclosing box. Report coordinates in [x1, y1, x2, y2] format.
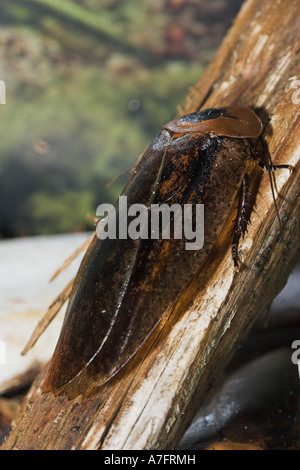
[3, 0, 300, 450]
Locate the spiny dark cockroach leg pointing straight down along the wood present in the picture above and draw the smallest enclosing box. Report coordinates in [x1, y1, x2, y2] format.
[231, 173, 251, 271]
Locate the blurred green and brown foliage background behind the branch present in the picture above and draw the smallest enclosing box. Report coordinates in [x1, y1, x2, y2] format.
[0, 0, 243, 237]
